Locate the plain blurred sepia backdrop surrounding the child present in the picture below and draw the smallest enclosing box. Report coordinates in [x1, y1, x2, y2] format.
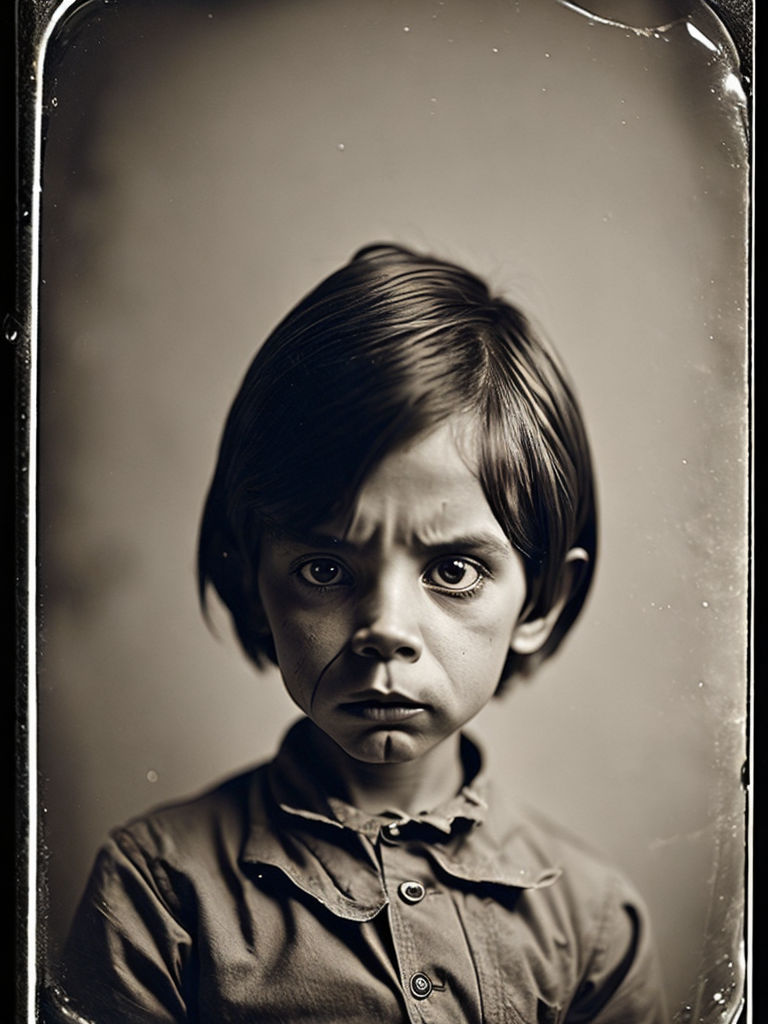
[38, 0, 748, 1021]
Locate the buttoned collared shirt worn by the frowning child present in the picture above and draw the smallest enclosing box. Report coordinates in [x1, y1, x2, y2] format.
[51, 720, 665, 1024]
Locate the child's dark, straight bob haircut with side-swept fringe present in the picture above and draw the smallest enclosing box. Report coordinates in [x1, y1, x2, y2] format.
[198, 245, 597, 688]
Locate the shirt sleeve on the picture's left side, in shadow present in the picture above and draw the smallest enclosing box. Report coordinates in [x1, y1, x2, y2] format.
[52, 830, 193, 1024]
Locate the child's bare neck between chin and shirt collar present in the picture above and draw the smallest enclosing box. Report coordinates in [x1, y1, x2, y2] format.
[314, 729, 464, 815]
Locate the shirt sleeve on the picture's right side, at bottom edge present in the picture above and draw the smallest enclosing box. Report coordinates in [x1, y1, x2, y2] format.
[565, 878, 669, 1024]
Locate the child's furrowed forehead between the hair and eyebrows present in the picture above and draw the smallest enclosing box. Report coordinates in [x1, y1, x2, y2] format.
[319, 421, 509, 547]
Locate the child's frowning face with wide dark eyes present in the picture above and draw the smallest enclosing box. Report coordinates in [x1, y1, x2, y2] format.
[258, 424, 525, 763]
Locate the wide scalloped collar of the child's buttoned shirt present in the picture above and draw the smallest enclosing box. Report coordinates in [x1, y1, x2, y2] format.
[243, 719, 560, 921]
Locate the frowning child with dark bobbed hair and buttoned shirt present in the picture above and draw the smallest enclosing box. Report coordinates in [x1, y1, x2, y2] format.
[49, 245, 665, 1024]
